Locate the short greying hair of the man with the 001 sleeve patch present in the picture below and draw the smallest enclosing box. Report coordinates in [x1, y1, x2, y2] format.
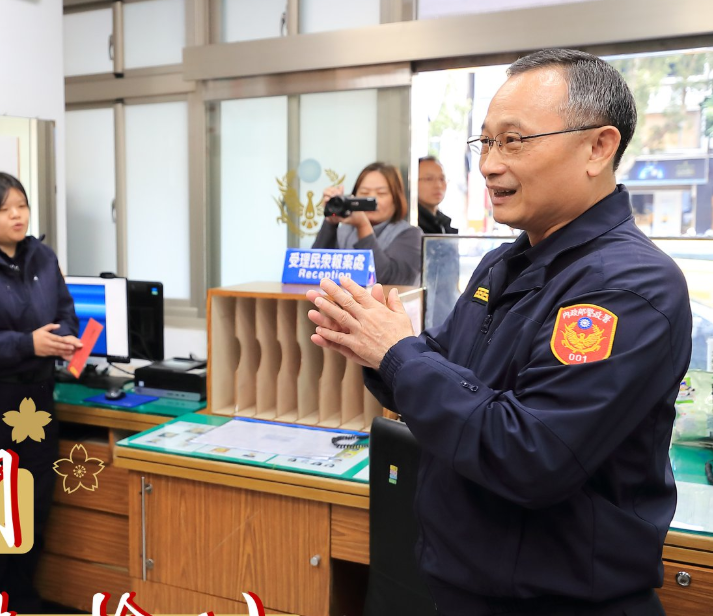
[507, 49, 636, 171]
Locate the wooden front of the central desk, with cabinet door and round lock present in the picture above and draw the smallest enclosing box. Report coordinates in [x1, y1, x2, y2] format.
[115, 447, 369, 616]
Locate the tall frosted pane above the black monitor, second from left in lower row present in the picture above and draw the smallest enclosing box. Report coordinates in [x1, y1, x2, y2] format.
[126, 102, 190, 299]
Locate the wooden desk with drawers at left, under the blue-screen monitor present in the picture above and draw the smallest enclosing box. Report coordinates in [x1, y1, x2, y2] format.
[37, 403, 171, 613]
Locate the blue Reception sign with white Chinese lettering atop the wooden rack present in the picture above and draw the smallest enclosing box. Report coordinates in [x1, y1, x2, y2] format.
[282, 248, 376, 287]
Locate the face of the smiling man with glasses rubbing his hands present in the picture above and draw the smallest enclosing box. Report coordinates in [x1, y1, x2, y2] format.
[480, 68, 598, 244]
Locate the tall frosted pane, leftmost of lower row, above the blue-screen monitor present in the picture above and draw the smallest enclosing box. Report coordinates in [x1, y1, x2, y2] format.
[65, 109, 116, 276]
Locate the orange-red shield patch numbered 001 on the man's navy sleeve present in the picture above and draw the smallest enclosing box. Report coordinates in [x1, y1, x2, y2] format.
[550, 304, 619, 364]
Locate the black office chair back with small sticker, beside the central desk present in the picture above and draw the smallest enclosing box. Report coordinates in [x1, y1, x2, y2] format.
[364, 417, 436, 616]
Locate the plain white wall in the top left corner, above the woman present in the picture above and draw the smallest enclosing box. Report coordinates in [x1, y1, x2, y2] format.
[0, 0, 67, 267]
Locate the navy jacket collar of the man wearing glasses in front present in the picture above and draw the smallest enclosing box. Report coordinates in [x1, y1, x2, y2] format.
[491, 184, 632, 296]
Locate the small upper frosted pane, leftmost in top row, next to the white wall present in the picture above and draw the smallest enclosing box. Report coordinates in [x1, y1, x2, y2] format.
[63, 9, 114, 77]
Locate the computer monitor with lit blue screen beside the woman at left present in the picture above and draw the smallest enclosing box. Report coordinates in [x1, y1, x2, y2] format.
[64, 276, 130, 362]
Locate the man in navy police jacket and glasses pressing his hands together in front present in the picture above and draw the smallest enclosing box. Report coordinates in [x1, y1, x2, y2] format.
[309, 50, 691, 616]
